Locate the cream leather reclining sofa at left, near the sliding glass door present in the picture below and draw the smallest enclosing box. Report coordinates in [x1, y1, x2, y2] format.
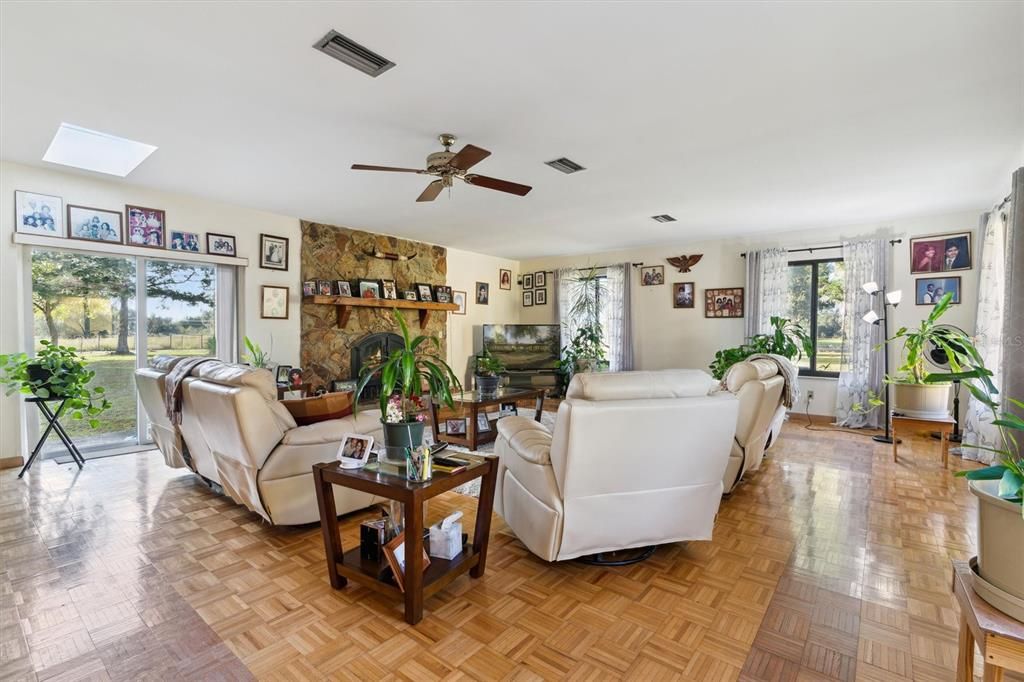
[135, 361, 383, 525]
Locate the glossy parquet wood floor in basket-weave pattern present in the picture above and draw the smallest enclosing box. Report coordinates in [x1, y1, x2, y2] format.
[0, 425, 1019, 681]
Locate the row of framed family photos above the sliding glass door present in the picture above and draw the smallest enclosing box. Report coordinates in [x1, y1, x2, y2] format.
[14, 189, 242, 258]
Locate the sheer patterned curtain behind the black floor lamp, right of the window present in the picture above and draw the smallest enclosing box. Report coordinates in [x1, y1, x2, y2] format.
[836, 240, 889, 428]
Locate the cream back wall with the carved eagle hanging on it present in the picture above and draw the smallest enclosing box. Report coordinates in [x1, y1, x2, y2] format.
[519, 208, 984, 415]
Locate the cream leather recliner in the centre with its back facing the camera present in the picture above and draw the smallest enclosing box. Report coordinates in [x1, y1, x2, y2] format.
[495, 370, 739, 561]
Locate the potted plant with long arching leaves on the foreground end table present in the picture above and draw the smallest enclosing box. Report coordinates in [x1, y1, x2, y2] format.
[355, 309, 462, 464]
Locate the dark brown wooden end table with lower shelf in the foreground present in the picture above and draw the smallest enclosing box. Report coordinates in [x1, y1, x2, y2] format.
[313, 453, 498, 625]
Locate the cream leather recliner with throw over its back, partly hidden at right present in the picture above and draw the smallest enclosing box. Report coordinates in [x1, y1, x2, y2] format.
[722, 359, 785, 493]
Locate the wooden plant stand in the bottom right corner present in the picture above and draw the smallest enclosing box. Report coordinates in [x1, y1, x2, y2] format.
[953, 561, 1024, 682]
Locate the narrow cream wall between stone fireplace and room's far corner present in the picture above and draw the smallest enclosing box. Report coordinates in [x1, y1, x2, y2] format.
[447, 249, 521, 386]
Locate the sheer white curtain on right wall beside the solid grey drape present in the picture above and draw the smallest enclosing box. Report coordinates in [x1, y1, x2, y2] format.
[961, 204, 1010, 464]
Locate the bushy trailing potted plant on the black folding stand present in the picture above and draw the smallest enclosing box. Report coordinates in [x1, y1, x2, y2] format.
[0, 340, 111, 429]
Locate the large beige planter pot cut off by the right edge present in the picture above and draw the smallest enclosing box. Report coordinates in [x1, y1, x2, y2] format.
[970, 480, 1024, 621]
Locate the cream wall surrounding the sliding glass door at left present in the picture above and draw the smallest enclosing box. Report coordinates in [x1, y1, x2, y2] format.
[0, 162, 302, 456]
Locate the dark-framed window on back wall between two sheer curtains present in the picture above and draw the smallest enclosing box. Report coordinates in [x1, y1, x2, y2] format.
[790, 258, 846, 377]
